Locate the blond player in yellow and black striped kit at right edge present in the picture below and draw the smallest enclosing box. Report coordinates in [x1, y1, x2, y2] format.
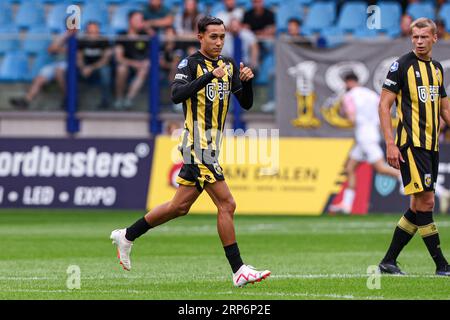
[379, 18, 450, 276]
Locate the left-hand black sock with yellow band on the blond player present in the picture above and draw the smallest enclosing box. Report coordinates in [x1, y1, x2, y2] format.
[382, 209, 417, 263]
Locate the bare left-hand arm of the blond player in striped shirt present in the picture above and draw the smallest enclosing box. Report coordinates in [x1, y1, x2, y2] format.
[378, 90, 404, 169]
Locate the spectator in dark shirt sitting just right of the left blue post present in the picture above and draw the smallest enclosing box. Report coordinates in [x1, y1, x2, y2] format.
[77, 22, 112, 109]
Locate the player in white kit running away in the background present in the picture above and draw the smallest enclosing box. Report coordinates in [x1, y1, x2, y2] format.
[329, 73, 402, 214]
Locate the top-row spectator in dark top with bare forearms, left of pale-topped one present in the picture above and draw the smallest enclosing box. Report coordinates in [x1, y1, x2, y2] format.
[143, 0, 173, 33]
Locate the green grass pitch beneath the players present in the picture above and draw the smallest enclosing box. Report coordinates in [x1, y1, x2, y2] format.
[0, 210, 450, 300]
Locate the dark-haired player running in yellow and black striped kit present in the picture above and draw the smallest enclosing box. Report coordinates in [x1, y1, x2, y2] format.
[111, 16, 270, 287]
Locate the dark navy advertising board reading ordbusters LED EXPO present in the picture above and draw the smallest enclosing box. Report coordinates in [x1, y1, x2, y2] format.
[0, 138, 153, 209]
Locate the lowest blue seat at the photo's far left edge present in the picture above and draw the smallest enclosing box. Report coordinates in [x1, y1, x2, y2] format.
[0, 51, 28, 81]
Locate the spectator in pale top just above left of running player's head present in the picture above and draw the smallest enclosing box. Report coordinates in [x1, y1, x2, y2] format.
[174, 0, 203, 38]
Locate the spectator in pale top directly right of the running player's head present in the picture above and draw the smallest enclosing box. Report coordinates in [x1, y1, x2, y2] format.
[222, 18, 259, 74]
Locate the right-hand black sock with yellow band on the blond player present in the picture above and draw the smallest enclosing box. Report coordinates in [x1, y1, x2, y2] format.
[417, 211, 448, 270]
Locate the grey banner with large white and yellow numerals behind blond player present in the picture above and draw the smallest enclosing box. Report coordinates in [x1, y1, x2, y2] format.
[276, 39, 450, 137]
